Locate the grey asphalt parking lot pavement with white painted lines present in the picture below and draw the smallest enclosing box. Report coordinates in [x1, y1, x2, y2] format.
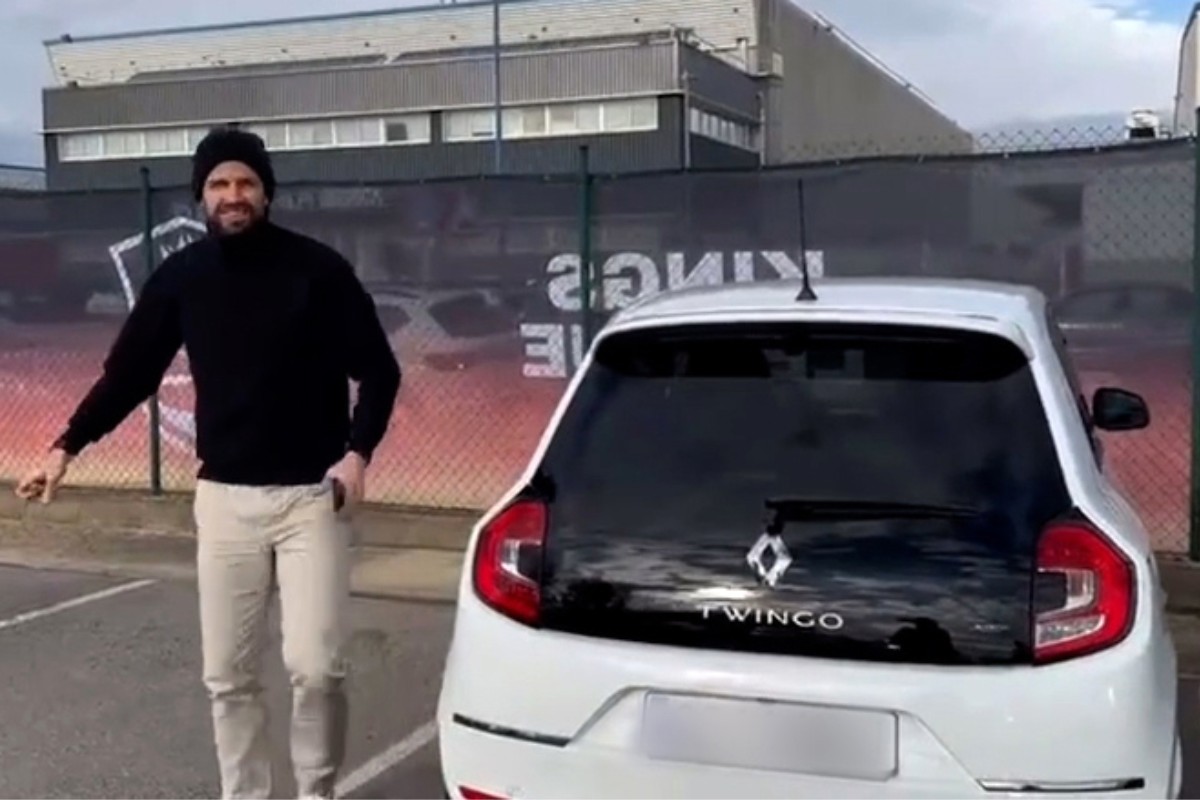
[0, 566, 1200, 798]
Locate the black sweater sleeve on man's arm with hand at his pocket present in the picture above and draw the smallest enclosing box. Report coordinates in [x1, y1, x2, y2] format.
[334, 250, 401, 462]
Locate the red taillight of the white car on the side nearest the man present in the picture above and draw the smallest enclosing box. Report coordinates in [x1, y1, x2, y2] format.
[473, 500, 546, 625]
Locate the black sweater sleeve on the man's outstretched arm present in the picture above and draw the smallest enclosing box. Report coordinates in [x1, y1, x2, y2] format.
[54, 259, 182, 456]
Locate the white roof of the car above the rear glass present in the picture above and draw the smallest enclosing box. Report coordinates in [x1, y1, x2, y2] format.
[611, 277, 1046, 329]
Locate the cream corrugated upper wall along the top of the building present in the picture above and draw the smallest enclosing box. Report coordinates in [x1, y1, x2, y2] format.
[47, 0, 755, 84]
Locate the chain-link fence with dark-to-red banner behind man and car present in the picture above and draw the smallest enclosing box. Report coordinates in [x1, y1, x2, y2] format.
[0, 131, 1195, 552]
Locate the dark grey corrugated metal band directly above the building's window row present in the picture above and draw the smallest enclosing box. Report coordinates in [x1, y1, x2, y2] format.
[43, 42, 686, 131]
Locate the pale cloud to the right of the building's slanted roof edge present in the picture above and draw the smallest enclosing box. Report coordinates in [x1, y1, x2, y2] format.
[802, 0, 1186, 128]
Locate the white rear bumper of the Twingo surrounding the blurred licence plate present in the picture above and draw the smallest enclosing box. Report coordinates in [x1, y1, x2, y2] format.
[438, 593, 1180, 798]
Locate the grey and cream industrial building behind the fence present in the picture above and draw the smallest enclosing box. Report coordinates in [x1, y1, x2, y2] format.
[43, 0, 972, 190]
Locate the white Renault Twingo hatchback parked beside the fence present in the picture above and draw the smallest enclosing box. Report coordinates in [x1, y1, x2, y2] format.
[438, 279, 1181, 799]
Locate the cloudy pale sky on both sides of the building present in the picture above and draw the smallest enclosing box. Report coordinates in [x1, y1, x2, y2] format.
[0, 0, 1193, 164]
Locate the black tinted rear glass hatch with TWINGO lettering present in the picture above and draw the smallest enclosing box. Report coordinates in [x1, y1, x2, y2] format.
[532, 324, 1069, 666]
